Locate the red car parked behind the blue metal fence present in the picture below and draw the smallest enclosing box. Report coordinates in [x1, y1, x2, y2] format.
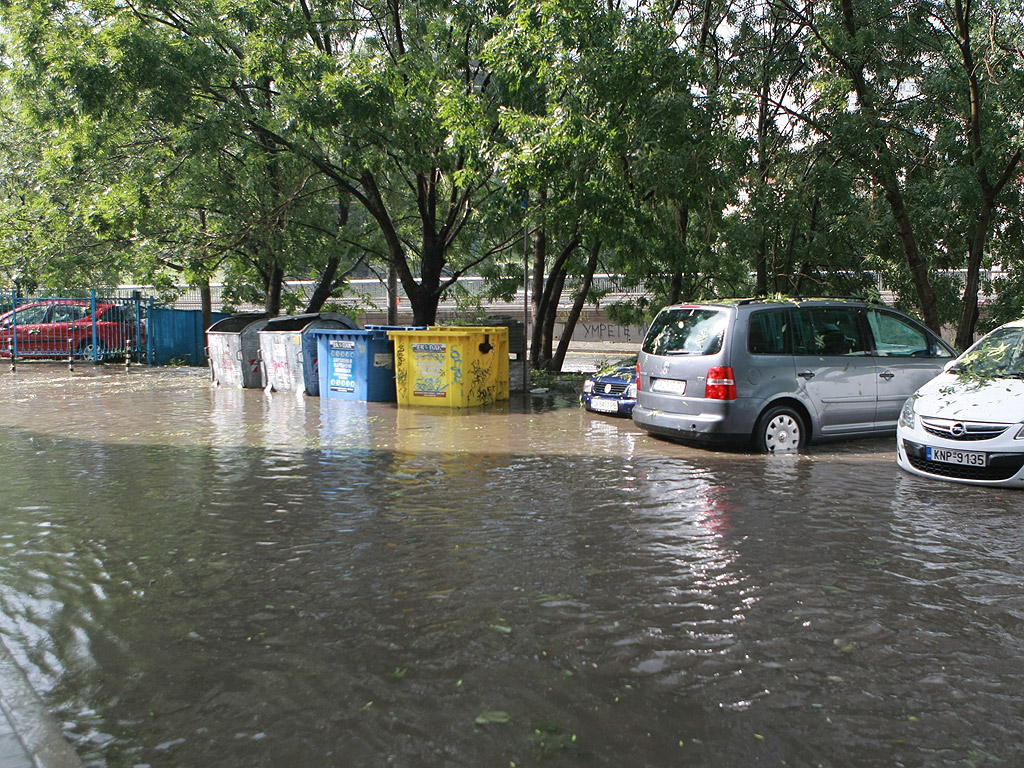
[0, 299, 137, 359]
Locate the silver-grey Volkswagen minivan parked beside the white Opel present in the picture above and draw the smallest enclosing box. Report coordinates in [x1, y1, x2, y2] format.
[633, 299, 955, 452]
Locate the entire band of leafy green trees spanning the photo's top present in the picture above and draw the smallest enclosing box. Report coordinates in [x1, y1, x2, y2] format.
[0, 0, 1024, 358]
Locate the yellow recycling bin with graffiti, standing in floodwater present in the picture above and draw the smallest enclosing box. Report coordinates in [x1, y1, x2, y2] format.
[388, 326, 509, 408]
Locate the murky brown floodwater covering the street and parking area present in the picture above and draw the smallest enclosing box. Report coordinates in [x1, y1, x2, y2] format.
[0, 365, 1024, 768]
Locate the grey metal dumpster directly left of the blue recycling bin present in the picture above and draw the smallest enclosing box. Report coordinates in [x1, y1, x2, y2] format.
[259, 312, 358, 397]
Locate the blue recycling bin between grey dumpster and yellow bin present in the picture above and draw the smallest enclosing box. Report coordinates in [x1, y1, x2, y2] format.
[312, 326, 423, 402]
